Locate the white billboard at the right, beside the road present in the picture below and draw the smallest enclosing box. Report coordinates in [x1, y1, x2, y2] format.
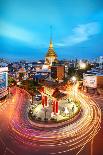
[83, 76, 97, 88]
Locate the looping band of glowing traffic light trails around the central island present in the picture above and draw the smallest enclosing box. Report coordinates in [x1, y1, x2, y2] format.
[9, 88, 101, 154]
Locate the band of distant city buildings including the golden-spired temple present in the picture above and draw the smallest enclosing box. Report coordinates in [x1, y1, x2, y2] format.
[1, 33, 103, 88]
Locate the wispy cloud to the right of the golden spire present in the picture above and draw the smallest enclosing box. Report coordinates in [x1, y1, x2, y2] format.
[55, 22, 100, 47]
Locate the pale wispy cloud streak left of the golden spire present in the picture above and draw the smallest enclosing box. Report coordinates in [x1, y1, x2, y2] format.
[0, 21, 43, 47]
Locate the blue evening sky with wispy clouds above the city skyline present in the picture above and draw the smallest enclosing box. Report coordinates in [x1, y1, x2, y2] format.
[0, 0, 103, 60]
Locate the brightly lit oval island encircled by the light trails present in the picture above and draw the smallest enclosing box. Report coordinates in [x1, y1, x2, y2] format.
[28, 98, 81, 126]
